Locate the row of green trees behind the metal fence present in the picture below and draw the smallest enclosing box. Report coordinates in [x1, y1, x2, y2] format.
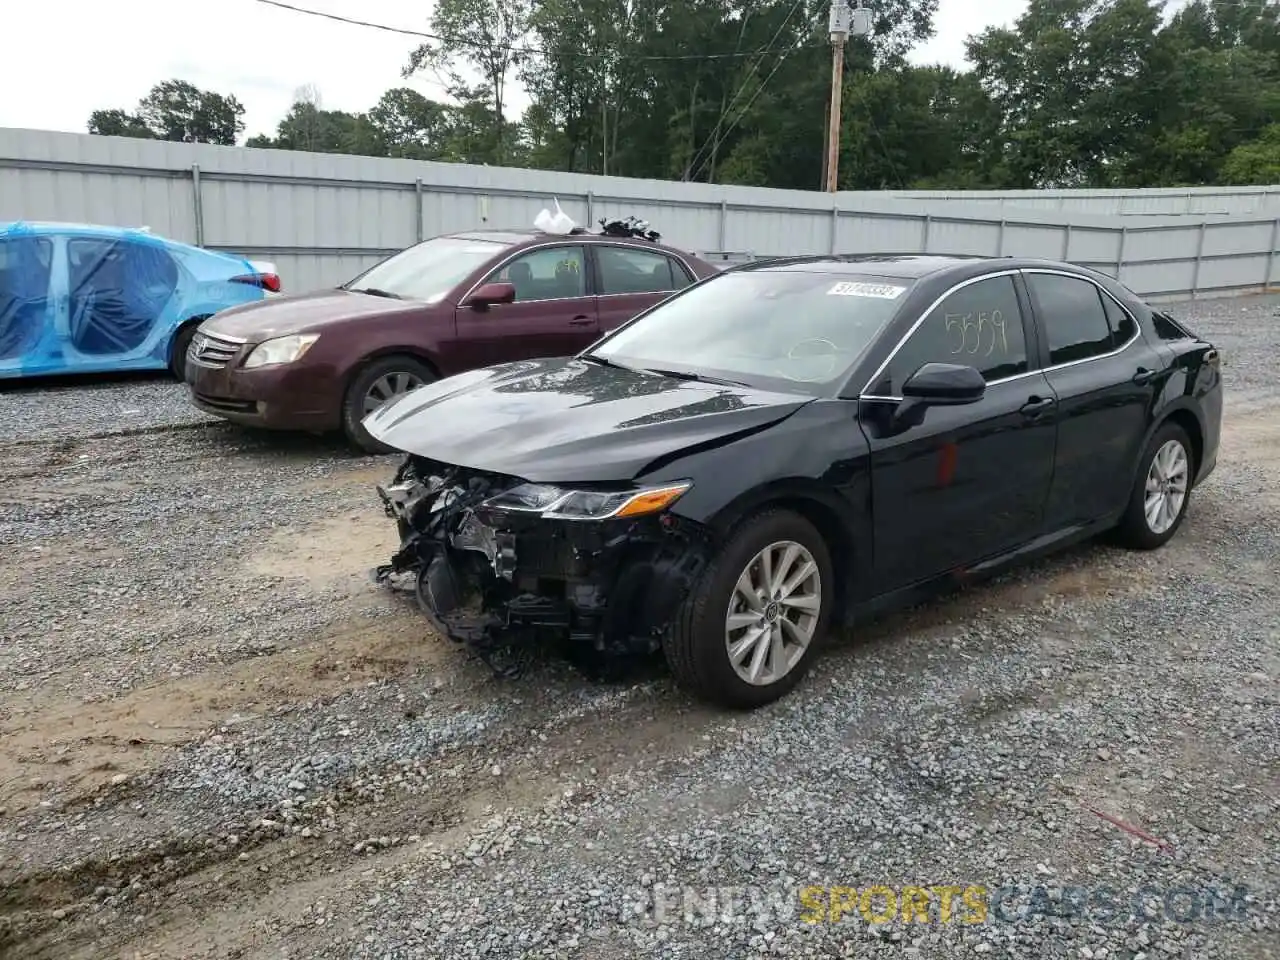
[110, 0, 1280, 189]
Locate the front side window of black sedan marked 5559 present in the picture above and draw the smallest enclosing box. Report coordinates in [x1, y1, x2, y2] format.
[881, 276, 1029, 396]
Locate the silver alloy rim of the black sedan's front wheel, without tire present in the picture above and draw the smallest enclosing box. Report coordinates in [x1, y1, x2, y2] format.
[724, 540, 822, 686]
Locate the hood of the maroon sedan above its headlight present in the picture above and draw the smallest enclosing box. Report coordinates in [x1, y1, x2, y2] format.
[201, 289, 426, 343]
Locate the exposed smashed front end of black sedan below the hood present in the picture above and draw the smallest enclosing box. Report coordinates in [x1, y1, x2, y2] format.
[375, 456, 710, 677]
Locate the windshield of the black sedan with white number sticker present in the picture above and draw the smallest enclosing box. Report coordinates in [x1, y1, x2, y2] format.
[591, 270, 910, 393]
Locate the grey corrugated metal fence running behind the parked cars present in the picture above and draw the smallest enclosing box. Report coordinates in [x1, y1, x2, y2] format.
[0, 129, 1280, 298]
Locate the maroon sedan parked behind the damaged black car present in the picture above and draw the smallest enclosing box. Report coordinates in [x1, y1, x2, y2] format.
[186, 230, 717, 452]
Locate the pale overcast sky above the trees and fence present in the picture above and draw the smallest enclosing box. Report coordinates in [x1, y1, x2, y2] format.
[0, 0, 1027, 137]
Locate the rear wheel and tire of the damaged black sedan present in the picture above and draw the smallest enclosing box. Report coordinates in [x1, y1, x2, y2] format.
[1116, 424, 1196, 550]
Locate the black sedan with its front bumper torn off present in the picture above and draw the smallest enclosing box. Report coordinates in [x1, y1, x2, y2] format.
[365, 256, 1222, 707]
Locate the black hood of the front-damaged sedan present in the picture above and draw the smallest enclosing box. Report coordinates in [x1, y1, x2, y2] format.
[365, 358, 810, 483]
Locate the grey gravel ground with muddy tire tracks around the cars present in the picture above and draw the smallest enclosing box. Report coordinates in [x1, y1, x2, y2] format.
[0, 297, 1280, 960]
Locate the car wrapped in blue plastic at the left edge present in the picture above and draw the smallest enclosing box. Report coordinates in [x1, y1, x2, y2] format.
[0, 223, 280, 379]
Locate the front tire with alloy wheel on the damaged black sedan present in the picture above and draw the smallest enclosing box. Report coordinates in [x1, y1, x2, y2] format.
[663, 509, 836, 709]
